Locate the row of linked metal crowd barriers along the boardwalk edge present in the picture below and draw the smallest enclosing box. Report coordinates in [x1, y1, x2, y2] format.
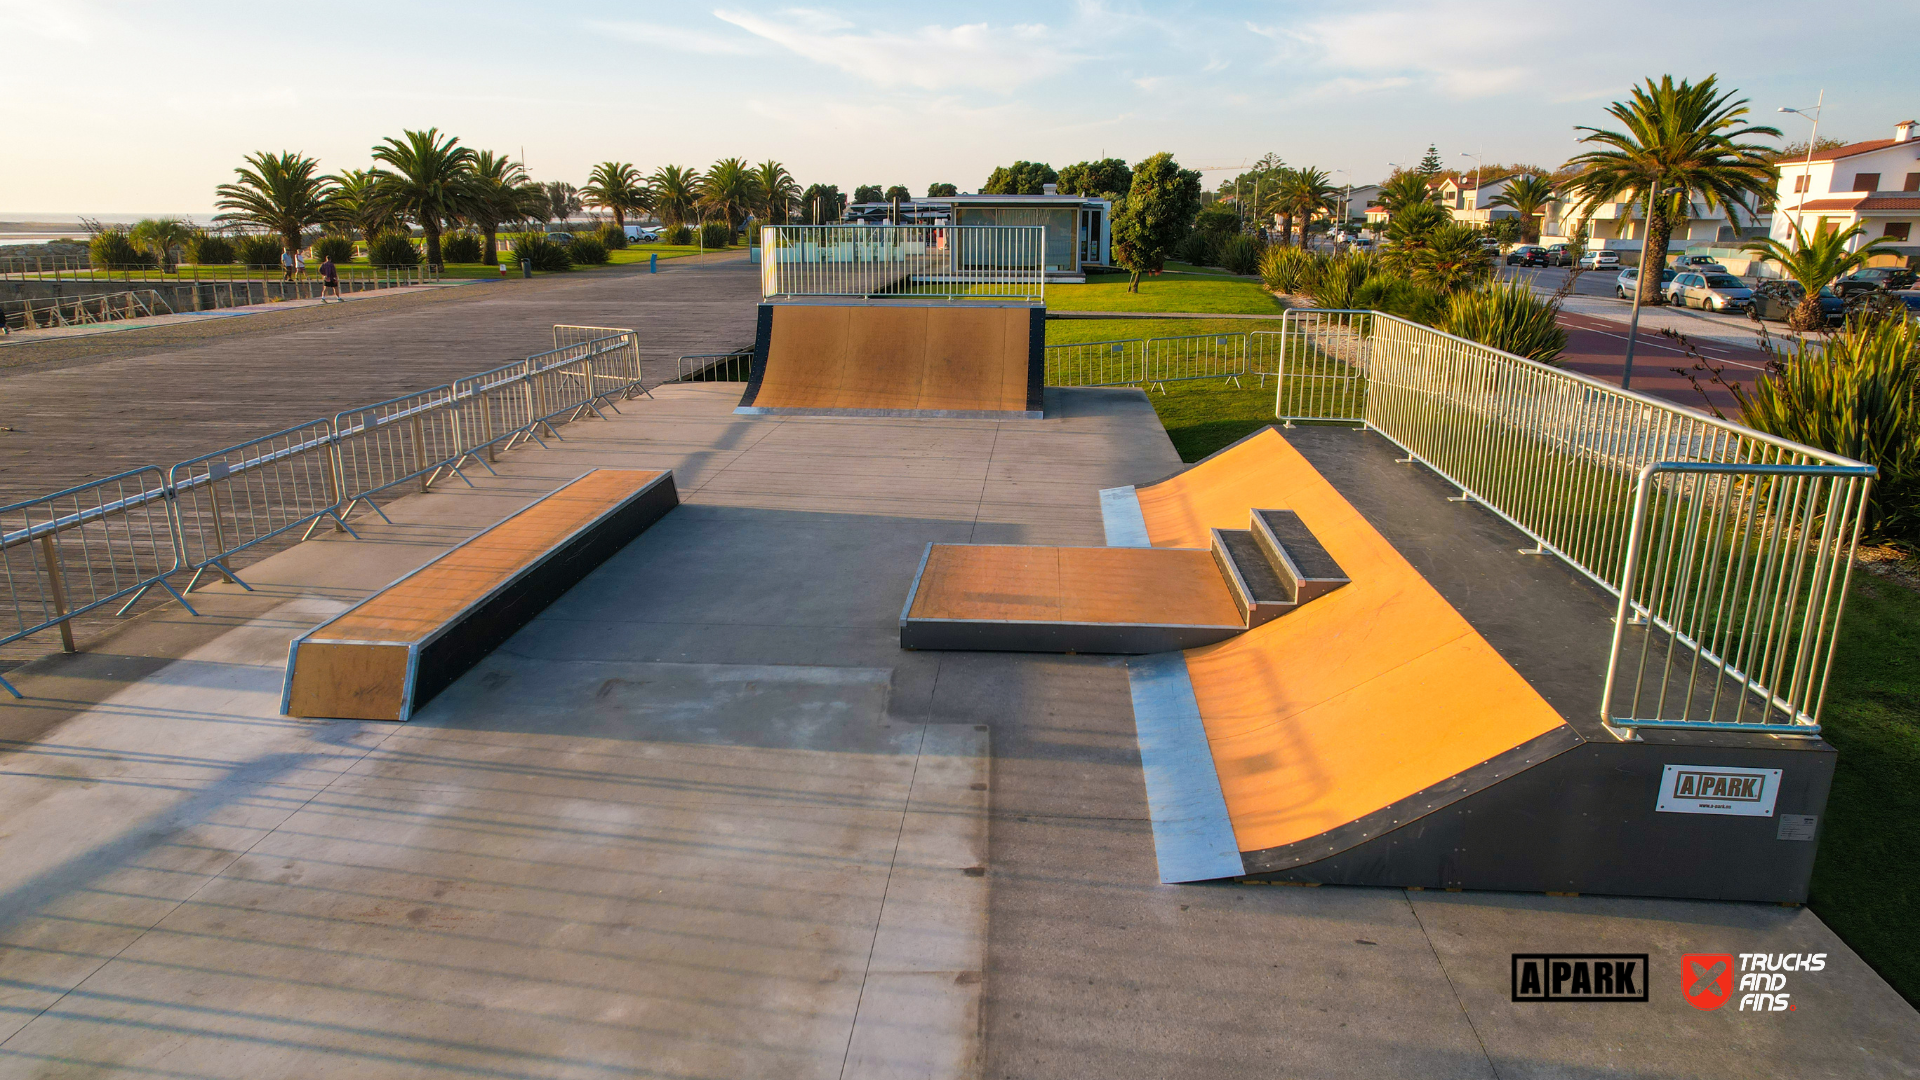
[0, 319, 645, 680]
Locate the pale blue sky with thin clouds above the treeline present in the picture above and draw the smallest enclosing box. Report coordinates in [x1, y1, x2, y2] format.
[0, 0, 1920, 221]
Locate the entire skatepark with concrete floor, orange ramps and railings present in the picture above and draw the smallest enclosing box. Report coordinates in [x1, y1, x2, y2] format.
[0, 237, 1920, 1078]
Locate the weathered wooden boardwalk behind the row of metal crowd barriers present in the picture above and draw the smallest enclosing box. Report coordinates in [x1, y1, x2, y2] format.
[0, 254, 758, 671]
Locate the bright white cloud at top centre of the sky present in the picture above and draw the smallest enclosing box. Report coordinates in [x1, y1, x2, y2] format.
[714, 10, 1083, 92]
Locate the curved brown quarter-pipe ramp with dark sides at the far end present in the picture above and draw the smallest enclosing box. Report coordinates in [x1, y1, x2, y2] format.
[735, 302, 1046, 419]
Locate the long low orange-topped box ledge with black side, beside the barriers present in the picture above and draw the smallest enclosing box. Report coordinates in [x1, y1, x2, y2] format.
[280, 469, 680, 721]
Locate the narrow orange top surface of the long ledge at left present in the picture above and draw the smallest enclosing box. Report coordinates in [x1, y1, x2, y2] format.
[321, 469, 660, 644]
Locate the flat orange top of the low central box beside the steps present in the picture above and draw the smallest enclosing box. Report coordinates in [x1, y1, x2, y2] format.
[908, 544, 1242, 626]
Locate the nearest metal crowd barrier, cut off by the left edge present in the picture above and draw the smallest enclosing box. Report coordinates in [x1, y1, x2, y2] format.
[0, 465, 192, 698]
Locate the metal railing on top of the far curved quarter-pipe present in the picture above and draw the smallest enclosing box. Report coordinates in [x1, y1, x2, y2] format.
[760, 225, 1046, 302]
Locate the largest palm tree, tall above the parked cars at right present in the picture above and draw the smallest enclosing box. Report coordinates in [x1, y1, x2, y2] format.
[1565, 75, 1780, 304]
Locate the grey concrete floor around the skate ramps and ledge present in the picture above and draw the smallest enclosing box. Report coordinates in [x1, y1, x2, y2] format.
[0, 384, 1920, 1080]
